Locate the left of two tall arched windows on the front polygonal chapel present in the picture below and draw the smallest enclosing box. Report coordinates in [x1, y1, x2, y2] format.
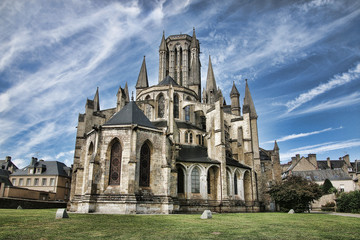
[109, 141, 122, 185]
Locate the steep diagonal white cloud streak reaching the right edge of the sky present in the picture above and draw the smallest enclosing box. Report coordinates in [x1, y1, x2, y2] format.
[285, 63, 360, 112]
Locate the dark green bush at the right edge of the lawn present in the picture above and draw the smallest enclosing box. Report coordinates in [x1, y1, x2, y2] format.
[336, 191, 360, 213]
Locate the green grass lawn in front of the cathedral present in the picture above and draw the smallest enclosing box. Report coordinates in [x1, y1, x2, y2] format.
[0, 209, 360, 240]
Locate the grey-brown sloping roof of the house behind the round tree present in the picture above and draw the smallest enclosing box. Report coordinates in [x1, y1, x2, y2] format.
[292, 169, 352, 181]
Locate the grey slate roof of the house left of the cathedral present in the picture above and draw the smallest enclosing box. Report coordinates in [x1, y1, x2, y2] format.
[11, 161, 71, 177]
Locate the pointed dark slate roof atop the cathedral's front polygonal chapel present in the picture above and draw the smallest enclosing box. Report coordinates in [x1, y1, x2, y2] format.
[104, 101, 157, 129]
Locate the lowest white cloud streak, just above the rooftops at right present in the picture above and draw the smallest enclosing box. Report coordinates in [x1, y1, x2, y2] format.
[280, 139, 360, 161]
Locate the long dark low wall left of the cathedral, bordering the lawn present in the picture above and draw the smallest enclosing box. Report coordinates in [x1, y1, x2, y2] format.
[0, 198, 67, 209]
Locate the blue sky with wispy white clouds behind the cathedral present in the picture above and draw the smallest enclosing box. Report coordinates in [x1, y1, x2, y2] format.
[0, 0, 360, 167]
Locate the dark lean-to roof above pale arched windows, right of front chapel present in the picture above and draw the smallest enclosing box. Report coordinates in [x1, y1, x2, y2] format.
[176, 145, 220, 164]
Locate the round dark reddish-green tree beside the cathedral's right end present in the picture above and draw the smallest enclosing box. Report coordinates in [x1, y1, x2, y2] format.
[268, 175, 322, 212]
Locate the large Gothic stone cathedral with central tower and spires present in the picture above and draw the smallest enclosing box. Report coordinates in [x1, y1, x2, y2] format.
[70, 30, 281, 214]
